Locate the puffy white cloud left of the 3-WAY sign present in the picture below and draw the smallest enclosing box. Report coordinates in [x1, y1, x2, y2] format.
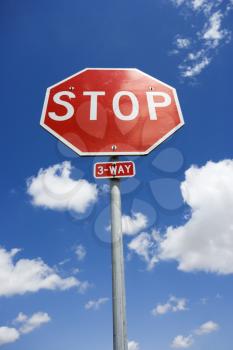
[27, 161, 98, 213]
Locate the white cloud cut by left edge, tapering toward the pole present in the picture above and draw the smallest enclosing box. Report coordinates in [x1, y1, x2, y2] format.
[0, 247, 88, 296]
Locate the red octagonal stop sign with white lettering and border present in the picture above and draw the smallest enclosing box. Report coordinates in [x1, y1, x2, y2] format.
[41, 68, 184, 155]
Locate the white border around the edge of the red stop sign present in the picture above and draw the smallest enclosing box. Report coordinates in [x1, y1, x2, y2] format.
[40, 68, 185, 156]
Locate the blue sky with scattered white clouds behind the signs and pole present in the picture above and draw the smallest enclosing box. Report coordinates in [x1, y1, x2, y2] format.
[0, 0, 233, 350]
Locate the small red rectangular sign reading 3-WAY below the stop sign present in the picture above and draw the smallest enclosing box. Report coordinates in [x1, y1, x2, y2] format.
[94, 161, 135, 179]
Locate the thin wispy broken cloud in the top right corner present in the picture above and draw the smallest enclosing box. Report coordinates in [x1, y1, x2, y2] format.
[170, 0, 233, 78]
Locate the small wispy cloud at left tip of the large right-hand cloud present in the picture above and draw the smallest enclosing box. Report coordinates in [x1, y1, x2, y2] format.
[128, 231, 160, 270]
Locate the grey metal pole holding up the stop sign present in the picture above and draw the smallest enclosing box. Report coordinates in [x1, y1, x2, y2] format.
[110, 157, 128, 350]
